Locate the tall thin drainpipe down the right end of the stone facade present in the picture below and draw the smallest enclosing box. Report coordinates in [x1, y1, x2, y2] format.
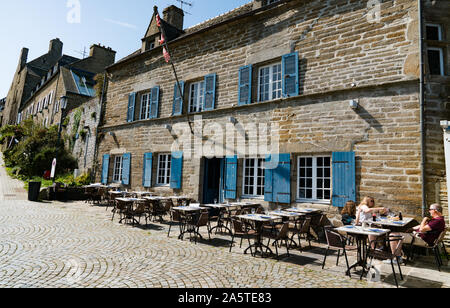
[418, 0, 427, 217]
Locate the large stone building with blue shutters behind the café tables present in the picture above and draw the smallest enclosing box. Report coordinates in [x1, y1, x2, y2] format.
[96, 0, 450, 226]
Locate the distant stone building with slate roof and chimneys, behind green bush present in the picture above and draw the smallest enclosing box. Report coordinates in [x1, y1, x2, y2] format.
[5, 40, 116, 176]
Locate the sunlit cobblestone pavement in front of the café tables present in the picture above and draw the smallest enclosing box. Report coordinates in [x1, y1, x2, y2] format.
[0, 201, 391, 288]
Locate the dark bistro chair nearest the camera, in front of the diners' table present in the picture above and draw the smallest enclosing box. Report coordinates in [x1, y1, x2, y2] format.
[360, 235, 404, 288]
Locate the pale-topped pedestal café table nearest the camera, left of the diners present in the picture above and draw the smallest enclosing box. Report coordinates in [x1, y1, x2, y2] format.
[335, 225, 391, 275]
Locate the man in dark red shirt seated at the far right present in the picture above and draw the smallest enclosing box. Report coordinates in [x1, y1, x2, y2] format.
[391, 203, 446, 264]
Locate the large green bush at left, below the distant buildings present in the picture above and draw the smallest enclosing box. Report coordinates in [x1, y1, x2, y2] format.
[0, 119, 77, 178]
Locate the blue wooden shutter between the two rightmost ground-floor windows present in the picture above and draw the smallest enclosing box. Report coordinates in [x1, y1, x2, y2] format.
[264, 154, 291, 204]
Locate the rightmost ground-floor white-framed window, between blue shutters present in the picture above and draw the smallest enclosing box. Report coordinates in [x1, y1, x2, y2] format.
[296, 155, 333, 204]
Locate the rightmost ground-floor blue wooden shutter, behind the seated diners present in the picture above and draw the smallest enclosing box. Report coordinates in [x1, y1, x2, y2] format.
[332, 152, 356, 207]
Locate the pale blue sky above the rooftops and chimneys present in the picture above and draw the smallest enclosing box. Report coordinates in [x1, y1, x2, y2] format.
[0, 0, 251, 99]
